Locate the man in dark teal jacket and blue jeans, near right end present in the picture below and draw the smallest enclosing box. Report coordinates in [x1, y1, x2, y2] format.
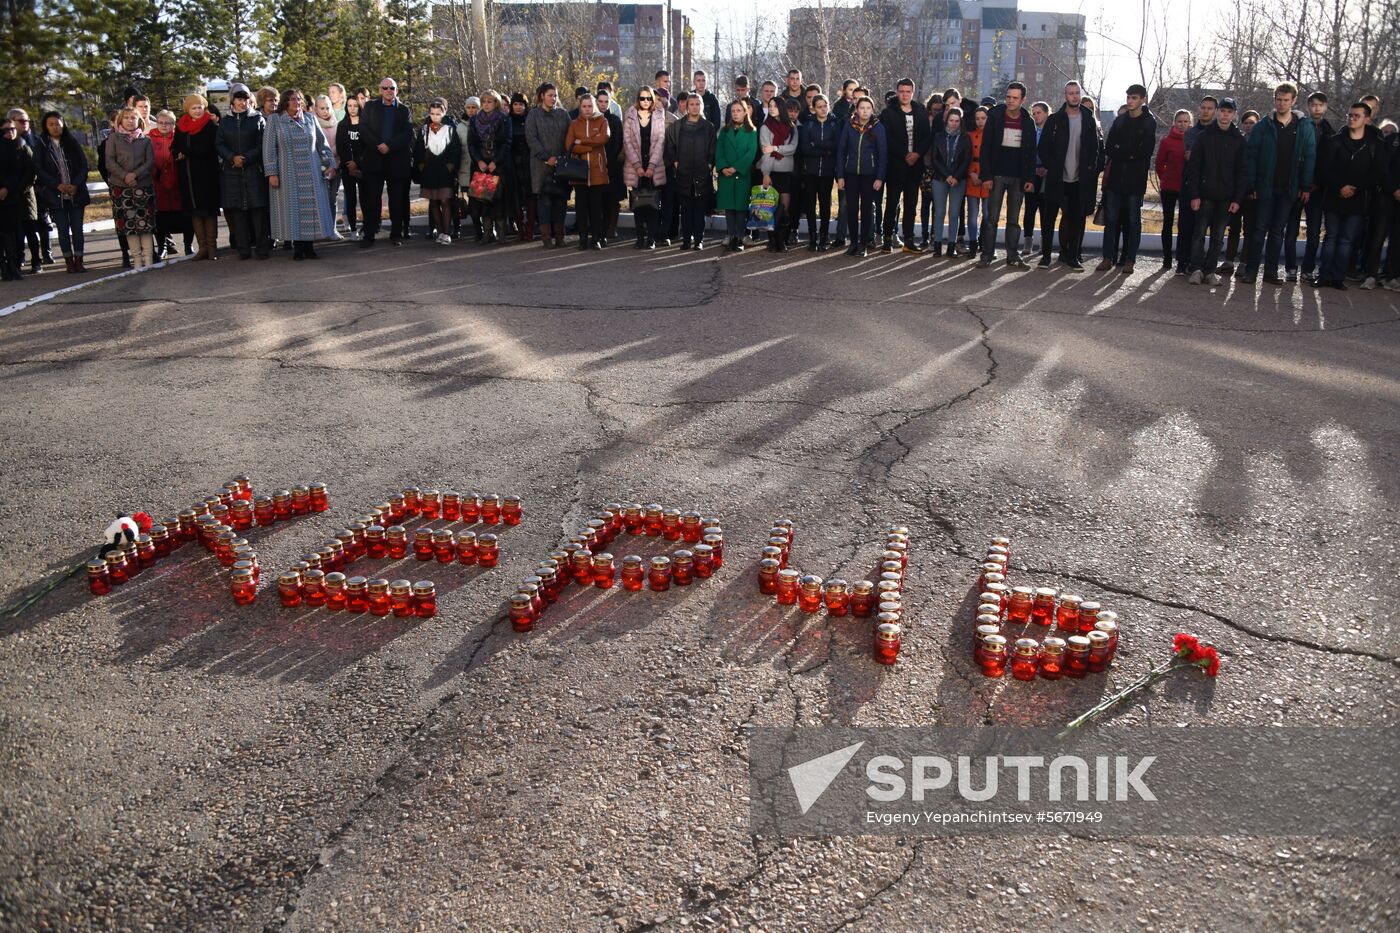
[1240, 83, 1317, 284]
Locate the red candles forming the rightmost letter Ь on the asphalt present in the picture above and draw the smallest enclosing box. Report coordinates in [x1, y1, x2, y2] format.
[973, 537, 1119, 681]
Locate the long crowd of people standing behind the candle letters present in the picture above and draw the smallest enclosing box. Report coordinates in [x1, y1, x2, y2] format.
[0, 69, 1400, 290]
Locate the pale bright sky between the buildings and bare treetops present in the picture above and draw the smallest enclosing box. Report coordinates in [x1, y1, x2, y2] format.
[672, 0, 1142, 106]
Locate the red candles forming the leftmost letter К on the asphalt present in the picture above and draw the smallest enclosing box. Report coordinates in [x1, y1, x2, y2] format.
[87, 475, 322, 598]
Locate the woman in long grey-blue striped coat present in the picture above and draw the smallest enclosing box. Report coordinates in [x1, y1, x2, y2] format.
[263, 88, 336, 259]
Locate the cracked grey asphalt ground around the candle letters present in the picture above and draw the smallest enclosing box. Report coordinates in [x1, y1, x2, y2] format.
[0, 226, 1400, 930]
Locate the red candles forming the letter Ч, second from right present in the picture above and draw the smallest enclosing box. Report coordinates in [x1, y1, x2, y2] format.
[759, 518, 909, 664]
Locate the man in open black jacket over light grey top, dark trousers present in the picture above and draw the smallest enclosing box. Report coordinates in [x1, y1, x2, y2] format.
[1040, 81, 1102, 272]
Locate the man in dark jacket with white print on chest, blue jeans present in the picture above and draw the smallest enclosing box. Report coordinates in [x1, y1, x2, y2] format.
[977, 81, 1036, 269]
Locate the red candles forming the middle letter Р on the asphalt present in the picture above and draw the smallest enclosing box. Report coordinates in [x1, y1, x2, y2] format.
[508, 502, 724, 632]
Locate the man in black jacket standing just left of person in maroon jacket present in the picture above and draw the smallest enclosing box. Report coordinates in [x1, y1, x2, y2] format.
[1096, 84, 1158, 275]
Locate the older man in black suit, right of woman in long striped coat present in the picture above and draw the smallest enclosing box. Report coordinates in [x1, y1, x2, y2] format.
[360, 78, 413, 243]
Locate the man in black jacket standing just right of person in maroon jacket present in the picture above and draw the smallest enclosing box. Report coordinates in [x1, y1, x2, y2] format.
[1182, 98, 1249, 286]
